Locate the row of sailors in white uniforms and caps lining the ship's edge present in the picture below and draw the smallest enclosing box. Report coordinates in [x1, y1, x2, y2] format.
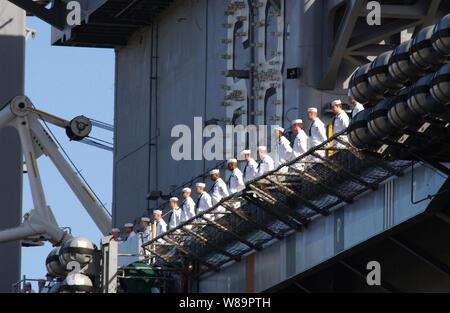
[111, 96, 364, 240]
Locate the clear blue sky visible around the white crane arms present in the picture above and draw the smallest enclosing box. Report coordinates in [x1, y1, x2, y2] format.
[22, 18, 114, 278]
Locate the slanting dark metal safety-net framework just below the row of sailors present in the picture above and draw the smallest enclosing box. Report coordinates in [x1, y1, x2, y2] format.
[143, 131, 410, 274]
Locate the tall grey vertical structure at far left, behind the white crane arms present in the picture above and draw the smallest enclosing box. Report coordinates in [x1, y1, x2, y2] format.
[0, 1, 25, 293]
